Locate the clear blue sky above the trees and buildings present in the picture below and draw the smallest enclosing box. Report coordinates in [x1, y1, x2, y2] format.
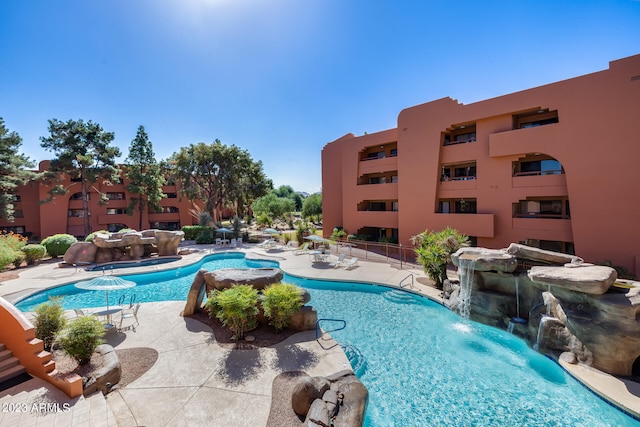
[0, 0, 640, 192]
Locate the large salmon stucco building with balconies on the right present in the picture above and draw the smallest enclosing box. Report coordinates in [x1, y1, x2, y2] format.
[322, 55, 640, 275]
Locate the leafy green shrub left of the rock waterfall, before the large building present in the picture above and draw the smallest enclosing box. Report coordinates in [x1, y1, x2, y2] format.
[411, 227, 469, 289]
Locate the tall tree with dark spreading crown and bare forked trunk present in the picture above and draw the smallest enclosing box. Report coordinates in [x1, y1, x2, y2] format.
[40, 119, 120, 236]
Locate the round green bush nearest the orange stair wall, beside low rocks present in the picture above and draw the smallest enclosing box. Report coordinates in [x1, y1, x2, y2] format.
[58, 316, 104, 365]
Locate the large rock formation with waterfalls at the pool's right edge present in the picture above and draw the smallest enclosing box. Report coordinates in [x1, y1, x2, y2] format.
[443, 244, 640, 375]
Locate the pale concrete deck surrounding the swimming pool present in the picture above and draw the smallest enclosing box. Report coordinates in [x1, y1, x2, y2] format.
[0, 245, 640, 427]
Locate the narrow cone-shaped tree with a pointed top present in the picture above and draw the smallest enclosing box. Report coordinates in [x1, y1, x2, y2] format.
[124, 126, 166, 230]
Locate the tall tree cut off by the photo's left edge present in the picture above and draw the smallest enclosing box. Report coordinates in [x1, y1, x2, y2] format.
[0, 117, 37, 221]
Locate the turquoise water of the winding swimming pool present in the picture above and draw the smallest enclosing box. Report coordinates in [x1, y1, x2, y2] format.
[18, 254, 640, 427]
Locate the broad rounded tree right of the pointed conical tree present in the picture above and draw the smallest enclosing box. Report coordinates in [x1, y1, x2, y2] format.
[168, 139, 272, 222]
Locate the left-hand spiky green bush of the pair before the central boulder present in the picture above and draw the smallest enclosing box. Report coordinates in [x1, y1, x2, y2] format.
[205, 285, 259, 338]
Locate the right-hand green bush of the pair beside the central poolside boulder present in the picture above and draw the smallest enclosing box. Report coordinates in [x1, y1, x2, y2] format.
[262, 283, 302, 331]
